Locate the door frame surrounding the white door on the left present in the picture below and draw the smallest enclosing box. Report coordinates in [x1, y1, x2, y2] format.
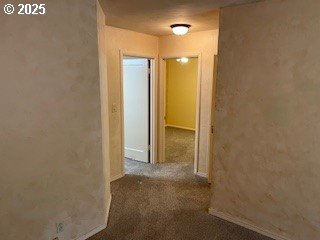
[119, 50, 158, 176]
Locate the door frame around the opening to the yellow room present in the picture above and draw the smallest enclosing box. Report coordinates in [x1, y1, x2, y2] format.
[158, 52, 202, 174]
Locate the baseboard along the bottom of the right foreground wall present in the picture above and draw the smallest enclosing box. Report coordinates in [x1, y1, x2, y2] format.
[209, 208, 290, 240]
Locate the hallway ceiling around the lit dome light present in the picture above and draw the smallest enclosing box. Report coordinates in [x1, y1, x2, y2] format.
[100, 0, 259, 36]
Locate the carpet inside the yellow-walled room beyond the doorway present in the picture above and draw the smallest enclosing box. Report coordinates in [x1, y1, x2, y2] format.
[165, 127, 195, 163]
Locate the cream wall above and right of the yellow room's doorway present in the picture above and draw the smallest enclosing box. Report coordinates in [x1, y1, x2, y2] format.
[159, 30, 219, 174]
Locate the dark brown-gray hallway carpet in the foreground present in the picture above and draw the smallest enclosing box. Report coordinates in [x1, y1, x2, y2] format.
[90, 160, 269, 240]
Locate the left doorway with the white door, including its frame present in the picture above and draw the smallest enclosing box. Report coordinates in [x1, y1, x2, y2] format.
[121, 53, 155, 174]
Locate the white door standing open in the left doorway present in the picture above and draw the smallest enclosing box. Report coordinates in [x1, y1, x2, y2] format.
[123, 59, 149, 162]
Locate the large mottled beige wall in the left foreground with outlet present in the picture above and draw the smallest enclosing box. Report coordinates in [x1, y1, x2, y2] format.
[0, 0, 110, 240]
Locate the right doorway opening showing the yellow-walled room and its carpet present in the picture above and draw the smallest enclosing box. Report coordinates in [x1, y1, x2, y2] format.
[162, 55, 200, 174]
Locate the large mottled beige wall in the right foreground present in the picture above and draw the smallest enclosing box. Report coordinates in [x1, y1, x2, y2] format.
[211, 0, 320, 240]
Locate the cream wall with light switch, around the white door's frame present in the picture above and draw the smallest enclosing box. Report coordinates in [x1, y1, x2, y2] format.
[106, 26, 158, 179]
